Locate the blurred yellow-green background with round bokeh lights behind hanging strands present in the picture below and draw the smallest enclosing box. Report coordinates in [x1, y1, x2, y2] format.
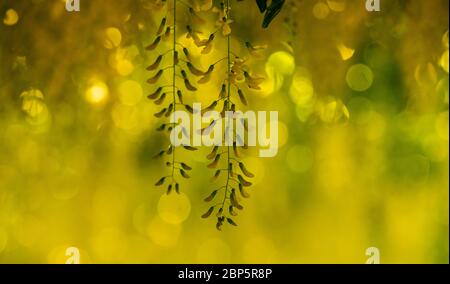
[0, 0, 449, 263]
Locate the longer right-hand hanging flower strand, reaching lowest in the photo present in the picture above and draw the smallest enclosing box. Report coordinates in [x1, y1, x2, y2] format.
[202, 0, 263, 230]
